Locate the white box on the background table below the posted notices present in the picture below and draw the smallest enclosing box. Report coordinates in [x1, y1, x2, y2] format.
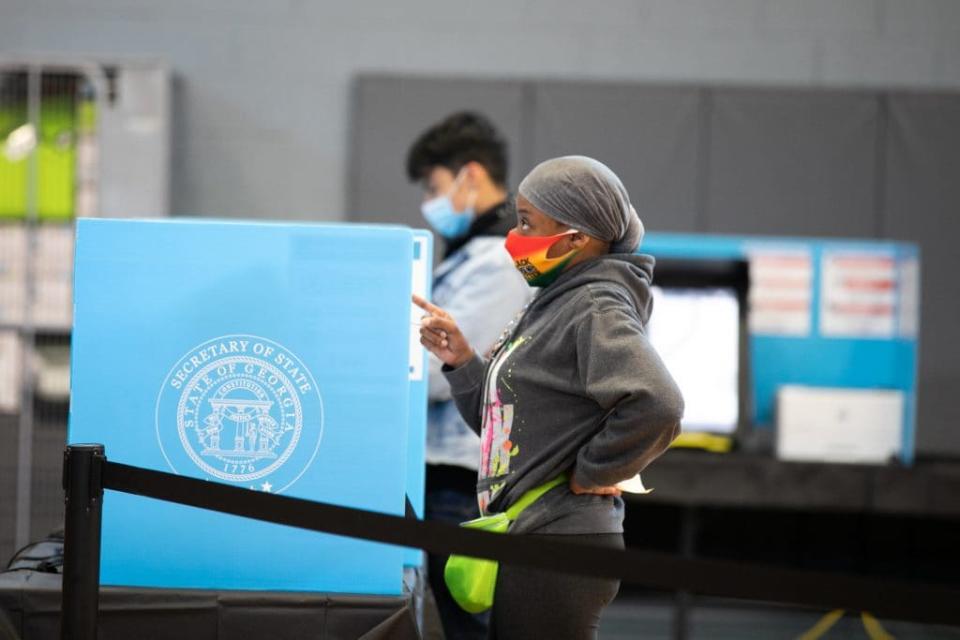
[777, 385, 904, 464]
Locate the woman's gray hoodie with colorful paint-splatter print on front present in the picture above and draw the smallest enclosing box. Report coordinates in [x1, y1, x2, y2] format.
[445, 254, 683, 534]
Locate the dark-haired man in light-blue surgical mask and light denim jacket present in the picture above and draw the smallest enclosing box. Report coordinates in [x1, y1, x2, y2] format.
[407, 112, 532, 638]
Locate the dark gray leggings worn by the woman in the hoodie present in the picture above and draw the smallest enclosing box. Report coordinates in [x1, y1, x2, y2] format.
[488, 533, 623, 640]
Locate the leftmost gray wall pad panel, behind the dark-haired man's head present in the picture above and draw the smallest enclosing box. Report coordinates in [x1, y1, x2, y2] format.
[348, 76, 524, 232]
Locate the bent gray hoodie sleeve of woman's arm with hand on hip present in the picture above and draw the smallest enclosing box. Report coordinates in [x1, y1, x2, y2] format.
[574, 289, 683, 488]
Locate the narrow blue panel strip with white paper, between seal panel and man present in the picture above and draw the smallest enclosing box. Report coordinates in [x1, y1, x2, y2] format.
[404, 229, 433, 567]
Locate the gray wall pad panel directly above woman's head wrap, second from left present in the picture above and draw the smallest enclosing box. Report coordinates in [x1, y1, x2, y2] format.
[533, 82, 701, 231]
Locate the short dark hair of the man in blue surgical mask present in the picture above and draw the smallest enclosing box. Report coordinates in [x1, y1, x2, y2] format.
[407, 111, 507, 186]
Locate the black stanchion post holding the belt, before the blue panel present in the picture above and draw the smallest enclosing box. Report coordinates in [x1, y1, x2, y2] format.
[60, 444, 106, 640]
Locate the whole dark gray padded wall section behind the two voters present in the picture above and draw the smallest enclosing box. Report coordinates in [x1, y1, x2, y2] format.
[348, 75, 960, 457]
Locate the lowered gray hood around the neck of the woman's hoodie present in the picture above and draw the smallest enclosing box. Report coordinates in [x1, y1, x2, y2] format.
[530, 253, 656, 325]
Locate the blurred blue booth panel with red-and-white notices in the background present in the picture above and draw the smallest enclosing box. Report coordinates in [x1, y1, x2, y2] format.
[640, 233, 919, 463]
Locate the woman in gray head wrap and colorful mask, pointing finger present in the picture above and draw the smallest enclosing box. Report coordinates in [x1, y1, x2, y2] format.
[415, 156, 683, 640]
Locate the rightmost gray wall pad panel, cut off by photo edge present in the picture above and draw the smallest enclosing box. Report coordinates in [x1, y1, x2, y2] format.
[884, 94, 960, 455]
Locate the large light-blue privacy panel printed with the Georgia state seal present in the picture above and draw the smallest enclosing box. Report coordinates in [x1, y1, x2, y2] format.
[69, 220, 413, 595]
